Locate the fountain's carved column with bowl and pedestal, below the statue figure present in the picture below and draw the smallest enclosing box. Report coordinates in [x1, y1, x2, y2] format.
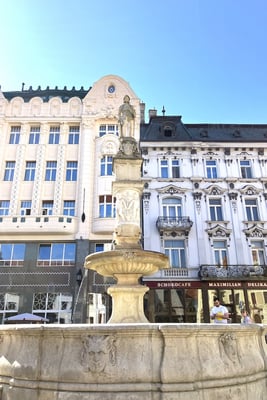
[85, 116, 169, 323]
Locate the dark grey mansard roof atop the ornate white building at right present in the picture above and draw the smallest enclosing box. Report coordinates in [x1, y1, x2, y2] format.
[140, 116, 267, 143]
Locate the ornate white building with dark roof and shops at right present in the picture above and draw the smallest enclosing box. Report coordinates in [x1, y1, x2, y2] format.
[140, 111, 267, 323]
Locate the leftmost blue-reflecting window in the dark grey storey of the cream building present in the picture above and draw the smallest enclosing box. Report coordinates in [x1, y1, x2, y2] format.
[0, 243, 25, 266]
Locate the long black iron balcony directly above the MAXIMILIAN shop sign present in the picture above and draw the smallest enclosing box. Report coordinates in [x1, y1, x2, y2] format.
[199, 264, 267, 280]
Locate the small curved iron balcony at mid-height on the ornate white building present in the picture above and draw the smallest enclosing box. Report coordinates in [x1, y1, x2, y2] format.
[156, 217, 193, 236]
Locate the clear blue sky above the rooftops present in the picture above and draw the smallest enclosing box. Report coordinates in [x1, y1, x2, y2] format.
[0, 0, 267, 124]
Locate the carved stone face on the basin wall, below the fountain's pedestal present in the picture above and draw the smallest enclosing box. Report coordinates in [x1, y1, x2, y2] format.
[81, 336, 117, 374]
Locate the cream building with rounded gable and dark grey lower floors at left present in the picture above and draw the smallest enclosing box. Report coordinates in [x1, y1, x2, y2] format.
[0, 75, 140, 323]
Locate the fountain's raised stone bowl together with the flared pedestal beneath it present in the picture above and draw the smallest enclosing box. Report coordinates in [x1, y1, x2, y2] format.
[85, 249, 169, 323]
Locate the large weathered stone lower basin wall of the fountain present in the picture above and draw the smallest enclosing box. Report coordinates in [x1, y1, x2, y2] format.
[0, 324, 267, 400]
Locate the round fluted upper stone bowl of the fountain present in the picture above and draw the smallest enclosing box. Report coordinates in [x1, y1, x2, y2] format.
[84, 249, 170, 285]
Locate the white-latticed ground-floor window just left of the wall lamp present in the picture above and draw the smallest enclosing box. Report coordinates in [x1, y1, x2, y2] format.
[32, 292, 72, 324]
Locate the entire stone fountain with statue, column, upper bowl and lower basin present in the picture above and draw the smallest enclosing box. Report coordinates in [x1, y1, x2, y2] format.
[0, 96, 267, 400]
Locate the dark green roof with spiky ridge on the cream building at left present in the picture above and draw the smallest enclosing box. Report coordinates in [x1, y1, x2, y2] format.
[2, 86, 91, 103]
